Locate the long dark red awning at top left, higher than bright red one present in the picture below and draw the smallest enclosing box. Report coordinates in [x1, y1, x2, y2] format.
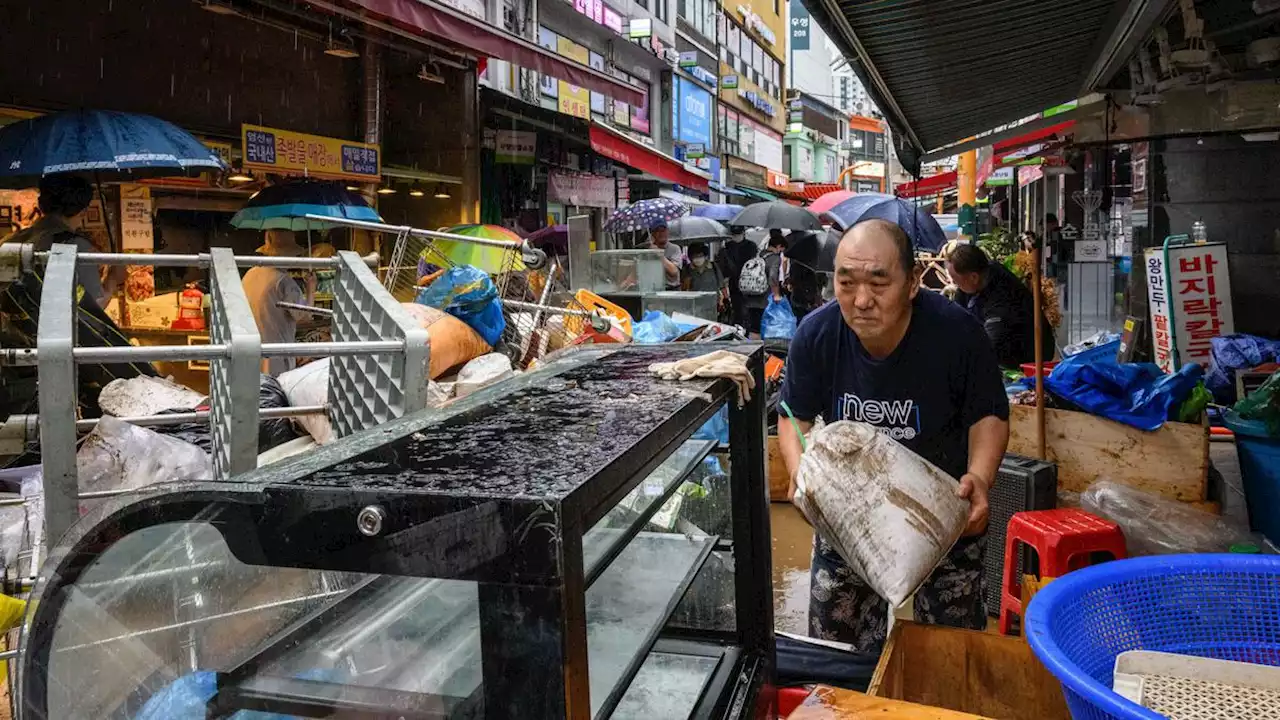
[344, 0, 644, 105]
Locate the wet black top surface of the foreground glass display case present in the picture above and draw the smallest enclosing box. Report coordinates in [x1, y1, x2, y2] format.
[273, 346, 718, 498]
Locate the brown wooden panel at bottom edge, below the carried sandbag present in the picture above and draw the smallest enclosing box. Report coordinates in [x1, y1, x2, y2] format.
[867, 620, 1071, 720]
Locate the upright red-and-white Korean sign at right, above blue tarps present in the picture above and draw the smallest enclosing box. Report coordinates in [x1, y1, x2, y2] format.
[1147, 242, 1235, 373]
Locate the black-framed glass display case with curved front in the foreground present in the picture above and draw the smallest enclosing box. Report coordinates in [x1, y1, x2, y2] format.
[15, 343, 774, 720]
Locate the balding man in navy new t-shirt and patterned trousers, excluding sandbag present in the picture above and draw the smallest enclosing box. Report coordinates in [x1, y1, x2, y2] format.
[778, 220, 1009, 652]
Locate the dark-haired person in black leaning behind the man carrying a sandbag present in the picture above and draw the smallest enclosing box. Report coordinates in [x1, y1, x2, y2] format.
[946, 240, 1055, 368]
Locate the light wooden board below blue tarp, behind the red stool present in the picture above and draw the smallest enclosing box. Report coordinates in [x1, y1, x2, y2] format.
[1009, 405, 1216, 502]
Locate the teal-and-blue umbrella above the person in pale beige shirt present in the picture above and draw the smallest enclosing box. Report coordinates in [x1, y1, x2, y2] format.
[232, 182, 383, 231]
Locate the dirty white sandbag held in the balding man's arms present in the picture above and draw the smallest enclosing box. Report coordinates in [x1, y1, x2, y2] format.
[795, 420, 969, 607]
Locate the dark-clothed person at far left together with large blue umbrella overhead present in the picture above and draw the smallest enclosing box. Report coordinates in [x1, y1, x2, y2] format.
[0, 110, 227, 416]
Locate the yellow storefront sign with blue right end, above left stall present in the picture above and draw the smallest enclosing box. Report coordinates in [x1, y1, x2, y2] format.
[241, 124, 383, 182]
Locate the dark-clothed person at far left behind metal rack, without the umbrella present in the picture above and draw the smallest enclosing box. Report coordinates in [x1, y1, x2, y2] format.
[0, 176, 157, 418]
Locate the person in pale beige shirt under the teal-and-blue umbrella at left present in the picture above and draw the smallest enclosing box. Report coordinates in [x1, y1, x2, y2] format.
[241, 229, 316, 375]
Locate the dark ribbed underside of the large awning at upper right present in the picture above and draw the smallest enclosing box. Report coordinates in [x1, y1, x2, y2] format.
[810, 0, 1130, 158]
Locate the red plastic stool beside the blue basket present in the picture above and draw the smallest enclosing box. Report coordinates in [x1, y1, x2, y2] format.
[1000, 510, 1126, 635]
